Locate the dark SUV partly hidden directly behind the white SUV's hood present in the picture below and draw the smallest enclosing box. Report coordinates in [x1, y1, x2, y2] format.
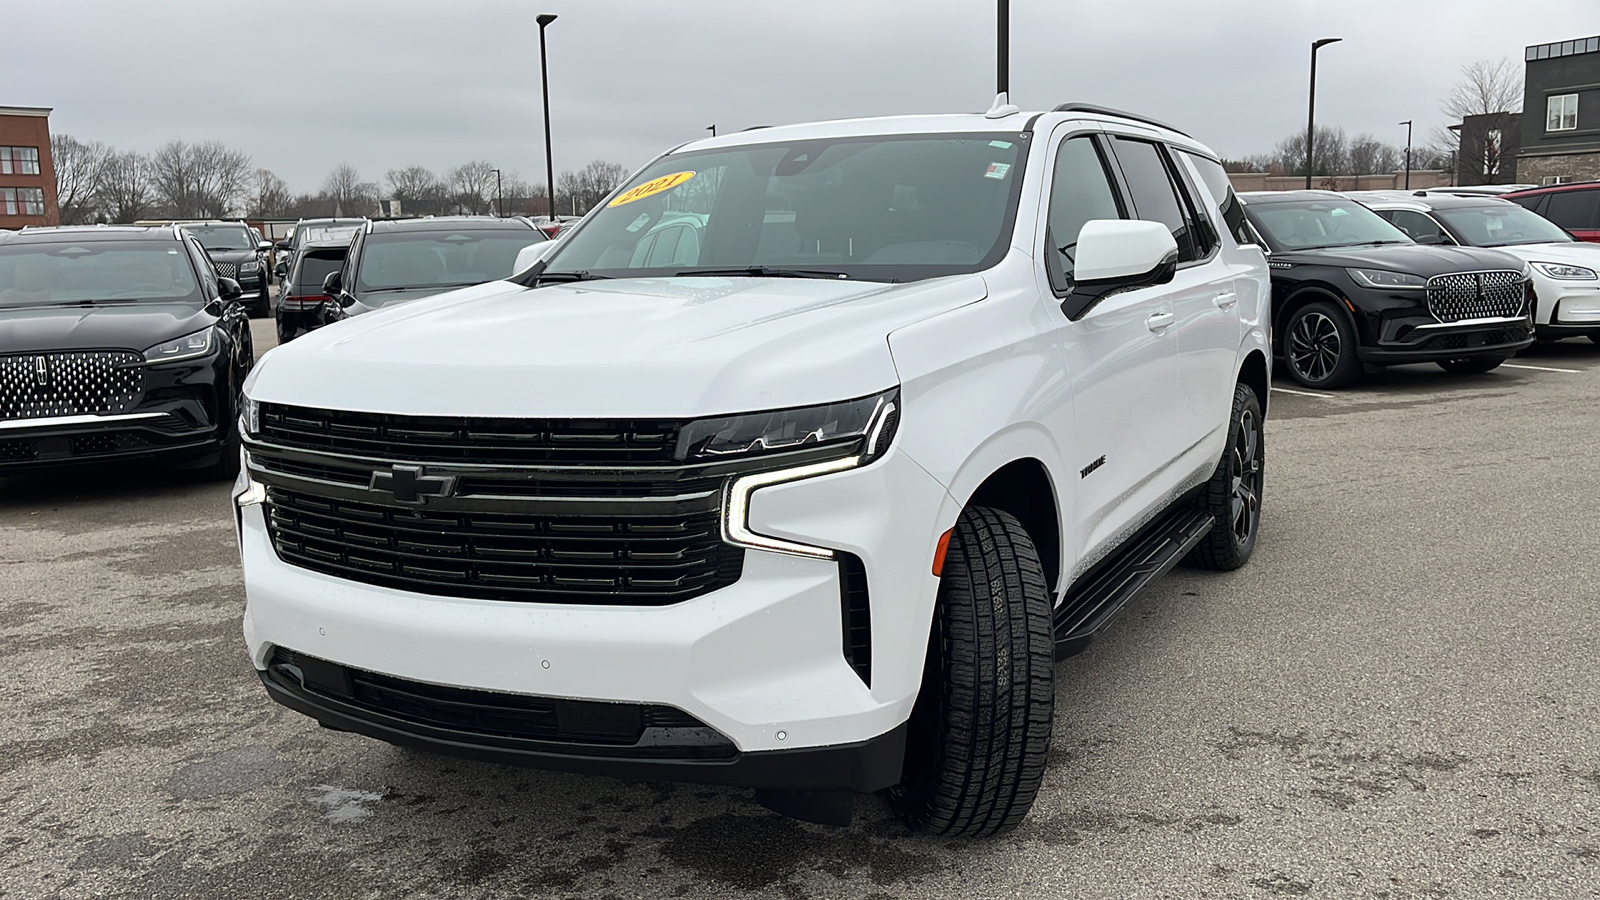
[323, 216, 550, 317]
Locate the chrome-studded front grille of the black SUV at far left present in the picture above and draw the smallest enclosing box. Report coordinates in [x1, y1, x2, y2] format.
[0, 351, 144, 420]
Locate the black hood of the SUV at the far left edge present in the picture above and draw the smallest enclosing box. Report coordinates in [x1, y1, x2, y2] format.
[0, 301, 216, 354]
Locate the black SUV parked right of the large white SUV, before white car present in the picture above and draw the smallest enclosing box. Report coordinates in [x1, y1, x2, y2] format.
[1240, 191, 1533, 388]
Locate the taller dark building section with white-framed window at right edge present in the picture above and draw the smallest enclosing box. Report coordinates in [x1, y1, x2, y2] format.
[1517, 35, 1600, 184]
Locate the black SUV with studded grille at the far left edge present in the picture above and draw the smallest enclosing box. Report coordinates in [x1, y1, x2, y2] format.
[0, 226, 256, 479]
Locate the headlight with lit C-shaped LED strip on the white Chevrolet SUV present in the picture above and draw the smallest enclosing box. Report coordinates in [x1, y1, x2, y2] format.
[700, 388, 899, 559]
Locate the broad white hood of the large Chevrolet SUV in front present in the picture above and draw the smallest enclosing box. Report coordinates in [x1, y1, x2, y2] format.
[246, 275, 986, 418]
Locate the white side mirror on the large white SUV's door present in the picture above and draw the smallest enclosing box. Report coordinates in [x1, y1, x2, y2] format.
[1061, 219, 1178, 319]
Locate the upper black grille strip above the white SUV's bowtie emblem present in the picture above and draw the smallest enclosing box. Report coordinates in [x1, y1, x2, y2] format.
[261, 404, 682, 464]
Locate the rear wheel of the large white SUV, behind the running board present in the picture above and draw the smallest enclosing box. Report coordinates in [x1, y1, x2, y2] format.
[1187, 384, 1266, 570]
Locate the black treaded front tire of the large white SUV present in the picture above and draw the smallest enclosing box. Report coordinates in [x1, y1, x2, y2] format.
[890, 506, 1056, 838]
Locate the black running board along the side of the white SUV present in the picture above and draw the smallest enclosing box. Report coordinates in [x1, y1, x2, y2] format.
[1054, 500, 1216, 661]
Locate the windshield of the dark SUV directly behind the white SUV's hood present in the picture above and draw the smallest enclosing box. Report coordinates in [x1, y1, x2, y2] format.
[355, 227, 549, 291]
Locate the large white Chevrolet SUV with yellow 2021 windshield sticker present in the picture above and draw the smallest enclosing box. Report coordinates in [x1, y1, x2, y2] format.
[235, 104, 1269, 834]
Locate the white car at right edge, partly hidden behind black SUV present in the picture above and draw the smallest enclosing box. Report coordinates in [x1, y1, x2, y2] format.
[1350, 191, 1600, 344]
